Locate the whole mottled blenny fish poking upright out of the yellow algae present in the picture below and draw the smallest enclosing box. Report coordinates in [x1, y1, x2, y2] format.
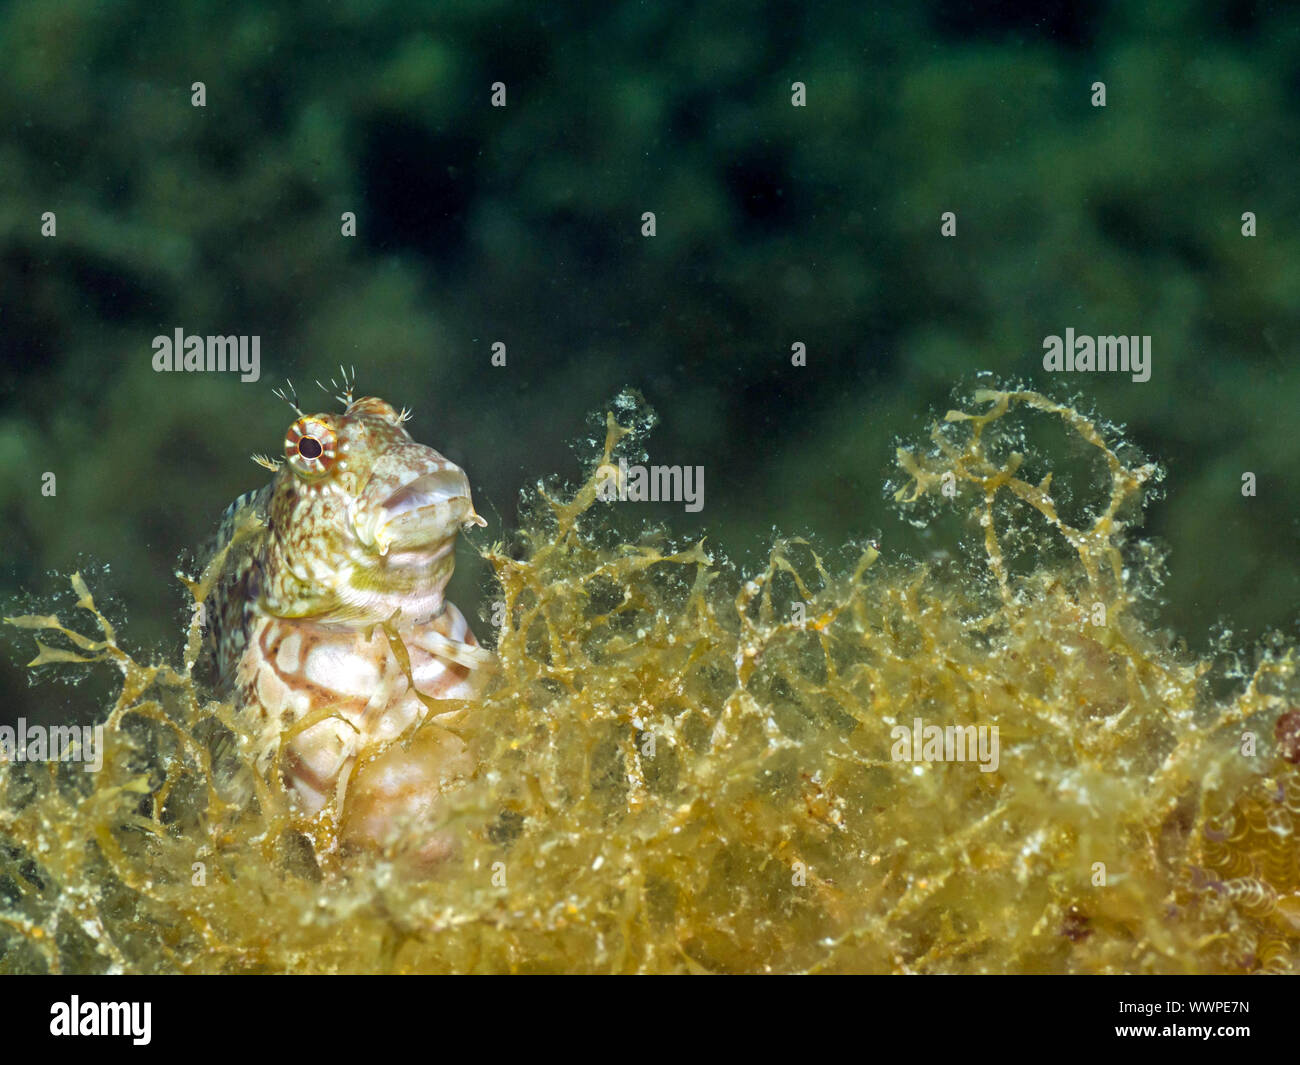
[204, 376, 494, 862]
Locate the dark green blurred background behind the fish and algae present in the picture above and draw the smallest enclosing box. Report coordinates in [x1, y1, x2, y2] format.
[0, 0, 1300, 718]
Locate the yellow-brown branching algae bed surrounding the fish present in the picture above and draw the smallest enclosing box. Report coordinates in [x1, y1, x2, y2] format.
[0, 390, 1300, 973]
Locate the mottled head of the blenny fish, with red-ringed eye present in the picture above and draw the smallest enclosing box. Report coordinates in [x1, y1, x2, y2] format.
[259, 397, 486, 625]
